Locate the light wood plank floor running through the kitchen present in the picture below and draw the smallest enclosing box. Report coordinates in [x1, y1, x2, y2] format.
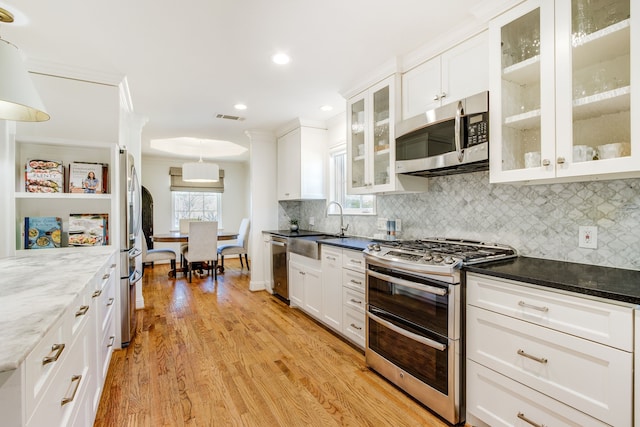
[95, 259, 447, 427]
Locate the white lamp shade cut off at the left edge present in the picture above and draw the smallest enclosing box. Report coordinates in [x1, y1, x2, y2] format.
[0, 39, 49, 122]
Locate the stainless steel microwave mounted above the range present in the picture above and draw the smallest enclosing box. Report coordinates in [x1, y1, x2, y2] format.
[396, 92, 489, 176]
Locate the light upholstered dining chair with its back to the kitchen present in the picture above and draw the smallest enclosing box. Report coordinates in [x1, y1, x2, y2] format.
[184, 221, 218, 282]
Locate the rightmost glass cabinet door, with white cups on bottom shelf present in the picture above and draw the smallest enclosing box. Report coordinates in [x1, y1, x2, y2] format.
[556, 0, 639, 176]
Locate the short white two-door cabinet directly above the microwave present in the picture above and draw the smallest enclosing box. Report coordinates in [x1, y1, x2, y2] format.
[402, 31, 489, 119]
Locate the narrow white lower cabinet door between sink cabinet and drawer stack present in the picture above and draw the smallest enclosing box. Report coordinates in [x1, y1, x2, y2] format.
[321, 245, 342, 331]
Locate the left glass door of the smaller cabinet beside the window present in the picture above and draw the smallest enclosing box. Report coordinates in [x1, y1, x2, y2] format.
[348, 97, 366, 189]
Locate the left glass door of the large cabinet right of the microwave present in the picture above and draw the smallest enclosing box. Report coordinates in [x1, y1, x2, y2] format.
[490, 0, 555, 182]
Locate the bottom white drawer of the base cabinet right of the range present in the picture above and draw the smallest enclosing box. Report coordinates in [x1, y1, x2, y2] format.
[466, 360, 608, 427]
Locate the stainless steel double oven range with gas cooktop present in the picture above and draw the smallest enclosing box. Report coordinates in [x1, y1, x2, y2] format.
[365, 238, 517, 424]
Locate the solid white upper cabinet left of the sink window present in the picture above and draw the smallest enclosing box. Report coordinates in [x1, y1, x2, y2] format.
[278, 121, 328, 200]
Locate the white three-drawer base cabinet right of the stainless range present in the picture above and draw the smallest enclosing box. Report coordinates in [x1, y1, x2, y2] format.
[466, 274, 633, 425]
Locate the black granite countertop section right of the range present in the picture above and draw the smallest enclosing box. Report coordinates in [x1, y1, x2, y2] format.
[463, 257, 640, 304]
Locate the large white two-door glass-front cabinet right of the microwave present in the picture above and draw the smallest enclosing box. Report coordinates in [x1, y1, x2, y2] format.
[490, 0, 640, 182]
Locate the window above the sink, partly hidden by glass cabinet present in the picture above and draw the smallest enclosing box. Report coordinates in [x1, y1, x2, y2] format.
[329, 145, 376, 215]
